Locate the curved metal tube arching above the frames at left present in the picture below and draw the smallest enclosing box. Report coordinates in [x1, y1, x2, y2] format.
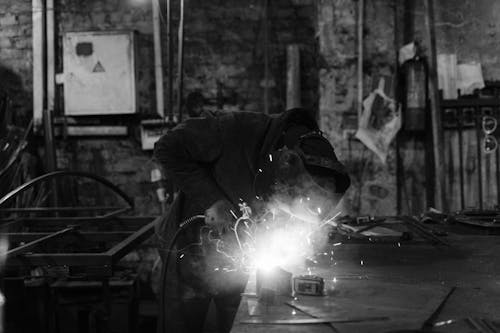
[0, 171, 134, 208]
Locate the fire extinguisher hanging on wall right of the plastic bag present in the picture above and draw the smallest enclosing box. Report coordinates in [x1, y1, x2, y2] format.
[402, 56, 427, 131]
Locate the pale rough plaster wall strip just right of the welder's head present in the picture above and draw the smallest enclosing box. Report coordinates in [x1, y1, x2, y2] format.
[318, 0, 396, 215]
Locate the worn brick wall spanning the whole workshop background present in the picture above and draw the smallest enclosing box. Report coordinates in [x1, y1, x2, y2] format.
[0, 0, 500, 214]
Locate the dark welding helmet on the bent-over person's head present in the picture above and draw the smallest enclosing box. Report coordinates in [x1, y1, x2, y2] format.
[255, 125, 350, 215]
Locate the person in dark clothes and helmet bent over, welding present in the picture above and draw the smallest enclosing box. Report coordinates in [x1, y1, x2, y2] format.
[154, 109, 350, 333]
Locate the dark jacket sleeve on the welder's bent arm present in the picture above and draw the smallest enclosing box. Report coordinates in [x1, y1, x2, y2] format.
[154, 118, 225, 212]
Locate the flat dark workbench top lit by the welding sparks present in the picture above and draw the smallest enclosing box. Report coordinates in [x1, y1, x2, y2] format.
[231, 233, 500, 333]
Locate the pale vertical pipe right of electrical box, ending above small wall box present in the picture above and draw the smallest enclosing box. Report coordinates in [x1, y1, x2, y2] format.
[152, 0, 165, 118]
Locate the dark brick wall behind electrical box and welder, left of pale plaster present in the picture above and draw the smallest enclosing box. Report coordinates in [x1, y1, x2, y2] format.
[0, 0, 317, 214]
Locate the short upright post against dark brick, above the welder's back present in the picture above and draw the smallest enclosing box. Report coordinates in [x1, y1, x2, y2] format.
[286, 44, 301, 110]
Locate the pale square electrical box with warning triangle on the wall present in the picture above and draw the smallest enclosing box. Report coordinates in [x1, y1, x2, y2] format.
[62, 31, 137, 116]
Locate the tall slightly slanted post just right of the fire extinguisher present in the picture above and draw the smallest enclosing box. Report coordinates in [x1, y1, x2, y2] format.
[424, 0, 448, 211]
